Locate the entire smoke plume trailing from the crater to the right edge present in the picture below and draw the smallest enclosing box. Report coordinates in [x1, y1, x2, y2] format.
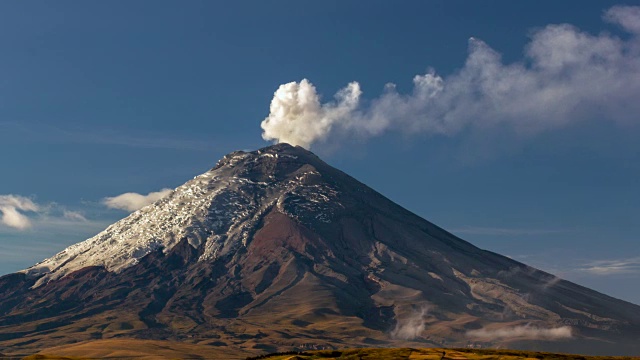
[261, 6, 640, 148]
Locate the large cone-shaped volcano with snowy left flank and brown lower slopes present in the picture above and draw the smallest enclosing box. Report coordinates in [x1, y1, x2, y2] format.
[0, 144, 640, 356]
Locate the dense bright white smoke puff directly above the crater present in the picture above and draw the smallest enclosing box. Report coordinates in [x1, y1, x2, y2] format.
[261, 79, 362, 148]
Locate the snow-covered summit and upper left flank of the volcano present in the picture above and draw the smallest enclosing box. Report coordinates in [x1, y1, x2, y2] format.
[23, 144, 336, 286]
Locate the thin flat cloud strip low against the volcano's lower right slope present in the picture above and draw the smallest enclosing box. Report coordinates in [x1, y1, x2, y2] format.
[467, 325, 572, 340]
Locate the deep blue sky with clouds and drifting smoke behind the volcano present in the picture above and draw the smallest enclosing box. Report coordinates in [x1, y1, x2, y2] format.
[0, 1, 640, 304]
